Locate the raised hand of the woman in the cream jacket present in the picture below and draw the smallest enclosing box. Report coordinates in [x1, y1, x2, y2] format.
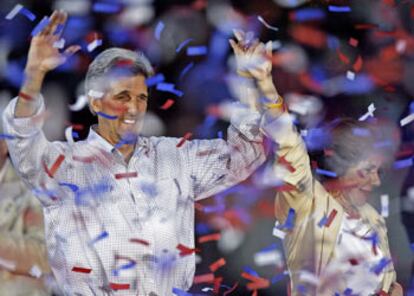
[229, 30, 272, 82]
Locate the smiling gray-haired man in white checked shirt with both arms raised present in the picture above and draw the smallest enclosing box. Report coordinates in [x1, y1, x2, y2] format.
[3, 11, 272, 296]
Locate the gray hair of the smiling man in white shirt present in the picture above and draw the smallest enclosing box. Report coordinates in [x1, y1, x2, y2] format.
[85, 47, 154, 115]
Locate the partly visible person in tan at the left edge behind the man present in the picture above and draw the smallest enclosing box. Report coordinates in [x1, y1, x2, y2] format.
[0, 140, 51, 296]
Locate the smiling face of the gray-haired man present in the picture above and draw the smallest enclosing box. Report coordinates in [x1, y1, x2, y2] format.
[92, 74, 148, 144]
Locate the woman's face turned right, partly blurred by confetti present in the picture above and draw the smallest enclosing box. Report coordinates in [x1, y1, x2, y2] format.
[340, 155, 384, 207]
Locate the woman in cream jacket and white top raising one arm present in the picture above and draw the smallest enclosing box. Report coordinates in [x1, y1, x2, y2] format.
[230, 31, 403, 295]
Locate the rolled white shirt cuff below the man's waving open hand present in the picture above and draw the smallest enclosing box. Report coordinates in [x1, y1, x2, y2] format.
[3, 95, 45, 138]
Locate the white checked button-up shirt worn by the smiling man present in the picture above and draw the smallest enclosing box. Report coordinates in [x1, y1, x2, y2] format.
[3, 98, 265, 296]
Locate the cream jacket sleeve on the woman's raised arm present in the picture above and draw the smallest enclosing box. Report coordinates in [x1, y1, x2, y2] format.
[261, 112, 313, 214]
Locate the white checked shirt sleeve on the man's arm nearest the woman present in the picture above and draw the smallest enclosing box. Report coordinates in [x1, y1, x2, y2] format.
[182, 104, 265, 200]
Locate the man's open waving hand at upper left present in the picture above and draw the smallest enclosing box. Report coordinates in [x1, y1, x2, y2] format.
[26, 10, 80, 75]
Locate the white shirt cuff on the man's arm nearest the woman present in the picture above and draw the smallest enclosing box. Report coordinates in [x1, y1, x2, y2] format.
[230, 103, 263, 142]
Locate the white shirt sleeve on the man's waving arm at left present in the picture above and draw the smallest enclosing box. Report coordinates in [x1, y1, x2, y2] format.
[3, 96, 64, 206]
